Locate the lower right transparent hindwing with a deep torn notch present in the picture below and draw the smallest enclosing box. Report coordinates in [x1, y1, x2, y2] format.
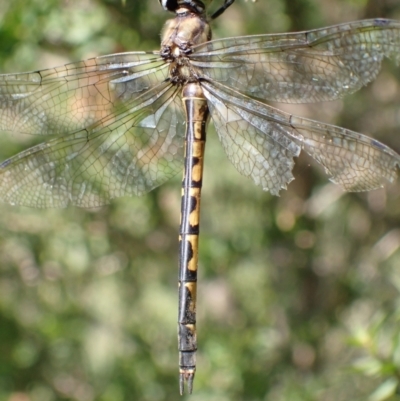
[202, 82, 400, 194]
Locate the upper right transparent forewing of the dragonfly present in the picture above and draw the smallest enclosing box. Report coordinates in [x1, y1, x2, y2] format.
[190, 19, 400, 103]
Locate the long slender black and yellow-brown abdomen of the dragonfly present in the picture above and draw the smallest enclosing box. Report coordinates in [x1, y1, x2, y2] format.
[178, 83, 209, 394]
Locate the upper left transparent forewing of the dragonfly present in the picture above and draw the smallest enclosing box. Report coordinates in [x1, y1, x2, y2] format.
[0, 52, 168, 135]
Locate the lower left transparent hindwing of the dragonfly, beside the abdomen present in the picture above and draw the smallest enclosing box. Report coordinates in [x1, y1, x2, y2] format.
[0, 82, 185, 207]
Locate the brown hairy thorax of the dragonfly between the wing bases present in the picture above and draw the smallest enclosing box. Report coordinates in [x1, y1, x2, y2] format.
[160, 9, 211, 84]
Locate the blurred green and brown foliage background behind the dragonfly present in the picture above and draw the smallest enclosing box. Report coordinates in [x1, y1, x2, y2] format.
[0, 0, 400, 401]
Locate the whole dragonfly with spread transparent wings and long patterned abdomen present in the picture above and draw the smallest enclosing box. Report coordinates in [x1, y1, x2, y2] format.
[0, 0, 400, 394]
